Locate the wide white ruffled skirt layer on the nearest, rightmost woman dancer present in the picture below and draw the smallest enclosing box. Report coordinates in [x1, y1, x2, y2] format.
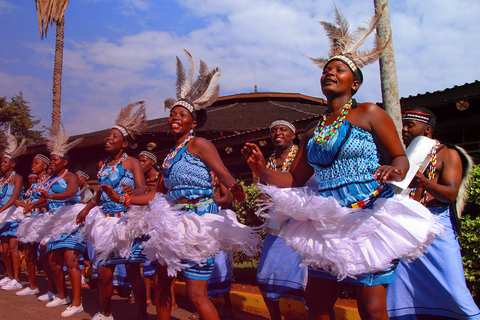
[258, 185, 443, 279]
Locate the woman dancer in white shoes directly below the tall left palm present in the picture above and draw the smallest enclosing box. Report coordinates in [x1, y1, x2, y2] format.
[32, 124, 86, 317]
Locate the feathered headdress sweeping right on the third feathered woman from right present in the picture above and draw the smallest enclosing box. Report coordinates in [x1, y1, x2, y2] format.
[111, 101, 147, 141]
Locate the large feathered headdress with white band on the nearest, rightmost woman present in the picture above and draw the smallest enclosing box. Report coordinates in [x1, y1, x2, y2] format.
[310, 5, 390, 82]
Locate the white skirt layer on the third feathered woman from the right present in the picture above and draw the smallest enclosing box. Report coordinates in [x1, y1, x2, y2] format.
[84, 206, 147, 262]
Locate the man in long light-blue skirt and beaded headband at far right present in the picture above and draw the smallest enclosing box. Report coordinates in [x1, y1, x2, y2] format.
[387, 108, 480, 319]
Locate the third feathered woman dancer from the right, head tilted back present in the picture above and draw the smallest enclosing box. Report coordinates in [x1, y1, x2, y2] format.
[77, 101, 147, 320]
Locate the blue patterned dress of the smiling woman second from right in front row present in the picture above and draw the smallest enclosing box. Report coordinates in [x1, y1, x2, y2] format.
[163, 145, 218, 280]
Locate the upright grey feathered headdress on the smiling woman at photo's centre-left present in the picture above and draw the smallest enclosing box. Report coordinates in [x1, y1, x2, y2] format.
[165, 50, 221, 116]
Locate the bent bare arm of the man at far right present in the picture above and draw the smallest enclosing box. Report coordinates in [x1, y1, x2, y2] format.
[410, 148, 462, 203]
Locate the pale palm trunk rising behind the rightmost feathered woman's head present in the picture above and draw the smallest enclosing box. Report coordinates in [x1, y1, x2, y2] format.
[373, 0, 402, 137]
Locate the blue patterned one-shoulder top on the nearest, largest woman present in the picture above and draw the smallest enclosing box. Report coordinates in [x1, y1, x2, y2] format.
[306, 121, 393, 206]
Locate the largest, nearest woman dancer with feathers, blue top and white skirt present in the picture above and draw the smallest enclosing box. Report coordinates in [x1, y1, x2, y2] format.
[242, 11, 441, 319]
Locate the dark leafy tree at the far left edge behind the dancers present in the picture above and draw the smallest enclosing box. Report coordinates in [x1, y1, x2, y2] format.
[0, 91, 42, 143]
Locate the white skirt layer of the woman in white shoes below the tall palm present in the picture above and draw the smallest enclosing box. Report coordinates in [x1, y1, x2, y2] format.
[38, 203, 85, 245]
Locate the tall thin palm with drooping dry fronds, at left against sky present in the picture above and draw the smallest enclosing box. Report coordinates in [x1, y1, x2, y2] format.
[35, 0, 70, 127]
